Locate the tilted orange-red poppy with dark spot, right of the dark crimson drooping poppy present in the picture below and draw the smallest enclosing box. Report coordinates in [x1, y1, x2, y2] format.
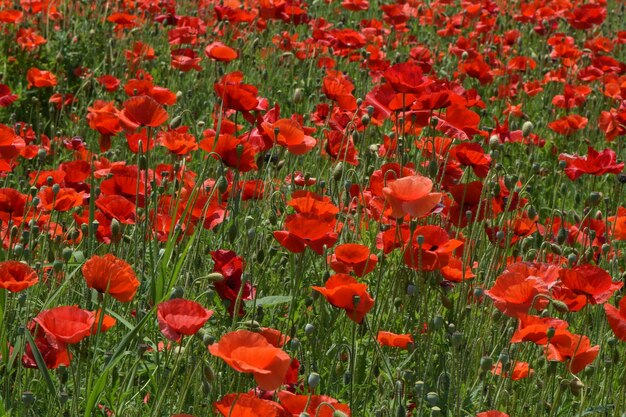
[311, 274, 374, 323]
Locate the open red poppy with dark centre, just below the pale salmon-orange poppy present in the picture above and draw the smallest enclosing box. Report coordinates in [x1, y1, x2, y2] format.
[404, 225, 463, 271]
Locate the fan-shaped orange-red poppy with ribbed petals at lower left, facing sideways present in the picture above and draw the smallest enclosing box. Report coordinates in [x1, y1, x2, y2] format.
[82, 253, 139, 303]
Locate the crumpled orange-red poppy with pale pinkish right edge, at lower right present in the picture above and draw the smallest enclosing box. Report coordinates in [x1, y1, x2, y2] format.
[485, 271, 549, 317]
